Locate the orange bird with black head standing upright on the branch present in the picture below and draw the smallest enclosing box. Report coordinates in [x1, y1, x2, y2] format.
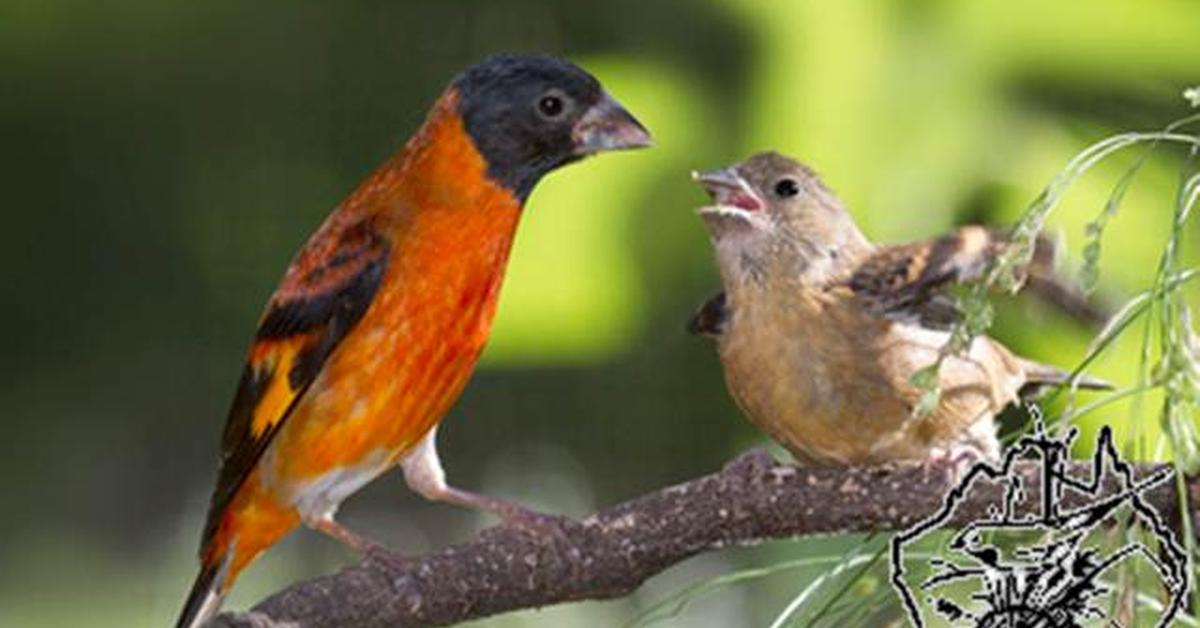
[176, 56, 650, 628]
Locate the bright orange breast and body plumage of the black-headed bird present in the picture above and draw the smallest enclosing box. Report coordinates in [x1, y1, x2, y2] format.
[270, 93, 521, 484]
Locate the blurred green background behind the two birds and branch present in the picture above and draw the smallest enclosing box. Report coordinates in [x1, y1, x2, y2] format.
[0, 0, 1200, 628]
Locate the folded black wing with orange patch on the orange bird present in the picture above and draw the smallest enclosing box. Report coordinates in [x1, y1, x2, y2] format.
[204, 216, 388, 544]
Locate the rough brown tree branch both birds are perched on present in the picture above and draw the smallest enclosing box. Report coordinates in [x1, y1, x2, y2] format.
[215, 450, 1200, 628]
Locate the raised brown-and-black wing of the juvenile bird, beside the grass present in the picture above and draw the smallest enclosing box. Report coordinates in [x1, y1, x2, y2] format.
[846, 227, 1008, 329]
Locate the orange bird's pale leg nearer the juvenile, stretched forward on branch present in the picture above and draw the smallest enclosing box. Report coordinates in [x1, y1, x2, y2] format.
[400, 427, 554, 530]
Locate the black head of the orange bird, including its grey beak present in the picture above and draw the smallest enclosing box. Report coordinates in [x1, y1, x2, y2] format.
[454, 55, 650, 202]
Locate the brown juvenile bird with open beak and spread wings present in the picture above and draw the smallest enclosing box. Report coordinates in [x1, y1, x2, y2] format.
[689, 152, 1105, 465]
